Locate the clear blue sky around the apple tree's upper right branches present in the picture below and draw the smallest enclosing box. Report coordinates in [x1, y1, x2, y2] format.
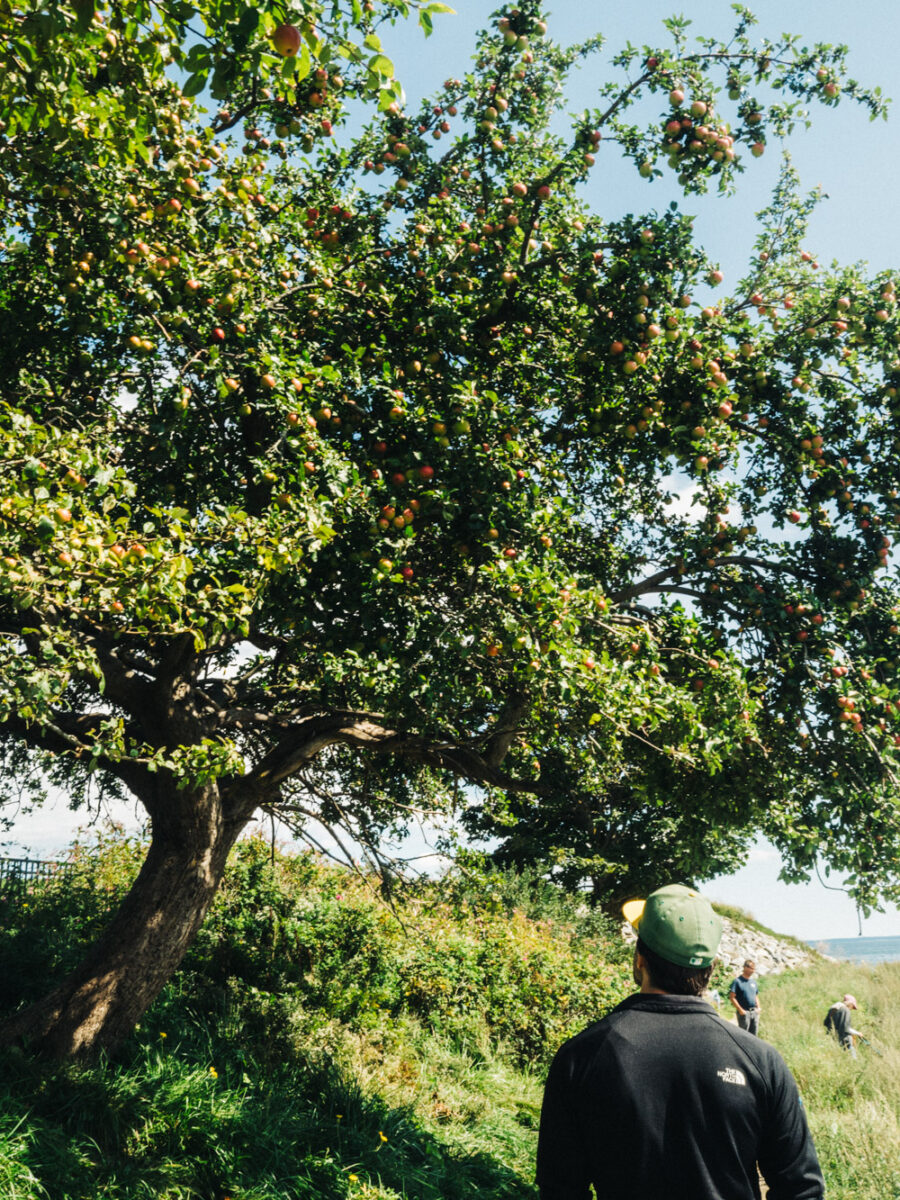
[382, 0, 900, 276]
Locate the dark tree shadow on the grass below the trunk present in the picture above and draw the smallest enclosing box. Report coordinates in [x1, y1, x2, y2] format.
[0, 1051, 535, 1200]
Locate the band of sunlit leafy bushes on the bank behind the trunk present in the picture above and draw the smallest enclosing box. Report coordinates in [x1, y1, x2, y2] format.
[0, 833, 630, 1066]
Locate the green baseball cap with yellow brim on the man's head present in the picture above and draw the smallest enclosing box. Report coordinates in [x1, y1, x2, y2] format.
[622, 883, 722, 967]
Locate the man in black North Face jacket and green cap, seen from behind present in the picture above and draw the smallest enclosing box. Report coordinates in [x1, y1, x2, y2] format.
[538, 884, 824, 1200]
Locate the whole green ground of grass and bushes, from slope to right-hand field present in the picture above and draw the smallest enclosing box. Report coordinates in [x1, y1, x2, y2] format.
[0, 840, 900, 1200]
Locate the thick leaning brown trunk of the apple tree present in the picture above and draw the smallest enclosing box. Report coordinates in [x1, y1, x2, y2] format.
[0, 787, 244, 1060]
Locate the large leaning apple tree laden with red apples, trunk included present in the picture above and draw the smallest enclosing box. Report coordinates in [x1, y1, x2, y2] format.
[0, 0, 900, 1056]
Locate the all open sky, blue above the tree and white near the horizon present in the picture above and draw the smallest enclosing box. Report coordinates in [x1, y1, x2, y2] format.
[7, 0, 900, 938]
